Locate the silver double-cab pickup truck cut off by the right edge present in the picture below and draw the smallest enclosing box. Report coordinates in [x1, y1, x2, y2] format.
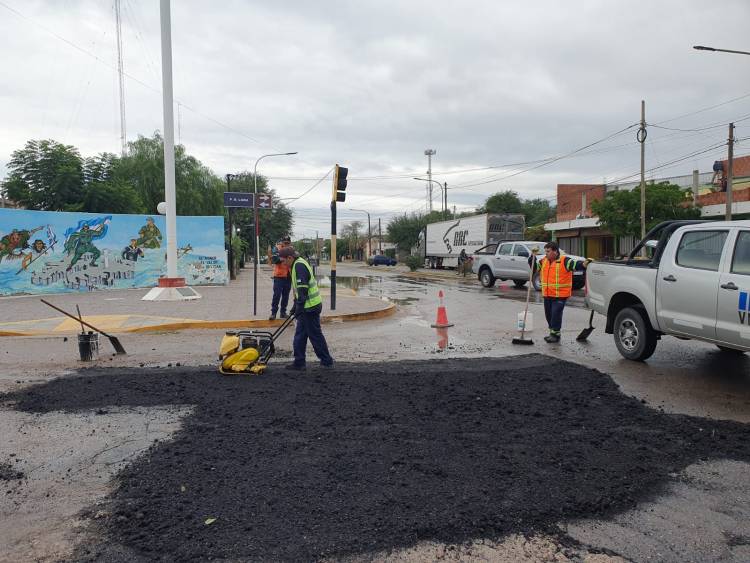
[586, 221, 750, 361]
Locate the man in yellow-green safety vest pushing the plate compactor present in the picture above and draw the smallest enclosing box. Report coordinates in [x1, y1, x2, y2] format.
[279, 246, 333, 370]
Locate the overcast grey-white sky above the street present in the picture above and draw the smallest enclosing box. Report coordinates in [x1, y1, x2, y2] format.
[0, 0, 750, 236]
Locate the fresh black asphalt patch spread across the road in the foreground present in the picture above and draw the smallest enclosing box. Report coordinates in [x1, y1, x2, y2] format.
[0, 355, 750, 561]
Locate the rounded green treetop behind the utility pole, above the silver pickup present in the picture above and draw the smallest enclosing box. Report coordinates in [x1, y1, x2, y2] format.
[591, 182, 701, 239]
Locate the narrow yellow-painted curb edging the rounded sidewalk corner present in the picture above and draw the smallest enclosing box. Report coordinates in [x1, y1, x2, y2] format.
[0, 303, 396, 337]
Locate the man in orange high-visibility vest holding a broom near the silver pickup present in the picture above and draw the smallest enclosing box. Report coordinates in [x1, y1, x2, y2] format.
[529, 242, 591, 344]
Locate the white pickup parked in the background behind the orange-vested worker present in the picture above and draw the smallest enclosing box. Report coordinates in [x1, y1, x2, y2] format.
[472, 240, 586, 291]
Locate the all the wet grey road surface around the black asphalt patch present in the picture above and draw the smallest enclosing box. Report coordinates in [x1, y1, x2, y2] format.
[0, 265, 750, 563]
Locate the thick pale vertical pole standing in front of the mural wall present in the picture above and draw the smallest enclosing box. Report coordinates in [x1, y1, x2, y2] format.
[160, 0, 177, 278]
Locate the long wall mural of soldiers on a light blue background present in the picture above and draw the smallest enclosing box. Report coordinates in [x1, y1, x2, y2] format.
[0, 209, 229, 295]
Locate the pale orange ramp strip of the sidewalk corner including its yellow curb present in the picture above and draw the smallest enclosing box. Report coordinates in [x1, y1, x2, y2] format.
[0, 303, 396, 336]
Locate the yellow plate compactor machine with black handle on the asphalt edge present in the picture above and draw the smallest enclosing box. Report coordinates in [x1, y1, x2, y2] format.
[219, 315, 296, 375]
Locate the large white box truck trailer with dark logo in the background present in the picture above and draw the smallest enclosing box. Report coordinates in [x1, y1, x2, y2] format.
[415, 213, 526, 268]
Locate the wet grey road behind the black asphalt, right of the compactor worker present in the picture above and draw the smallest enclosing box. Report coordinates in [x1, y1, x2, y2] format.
[326, 266, 750, 422]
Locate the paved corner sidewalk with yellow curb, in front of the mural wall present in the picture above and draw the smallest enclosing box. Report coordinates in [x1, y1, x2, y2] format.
[0, 265, 396, 336]
